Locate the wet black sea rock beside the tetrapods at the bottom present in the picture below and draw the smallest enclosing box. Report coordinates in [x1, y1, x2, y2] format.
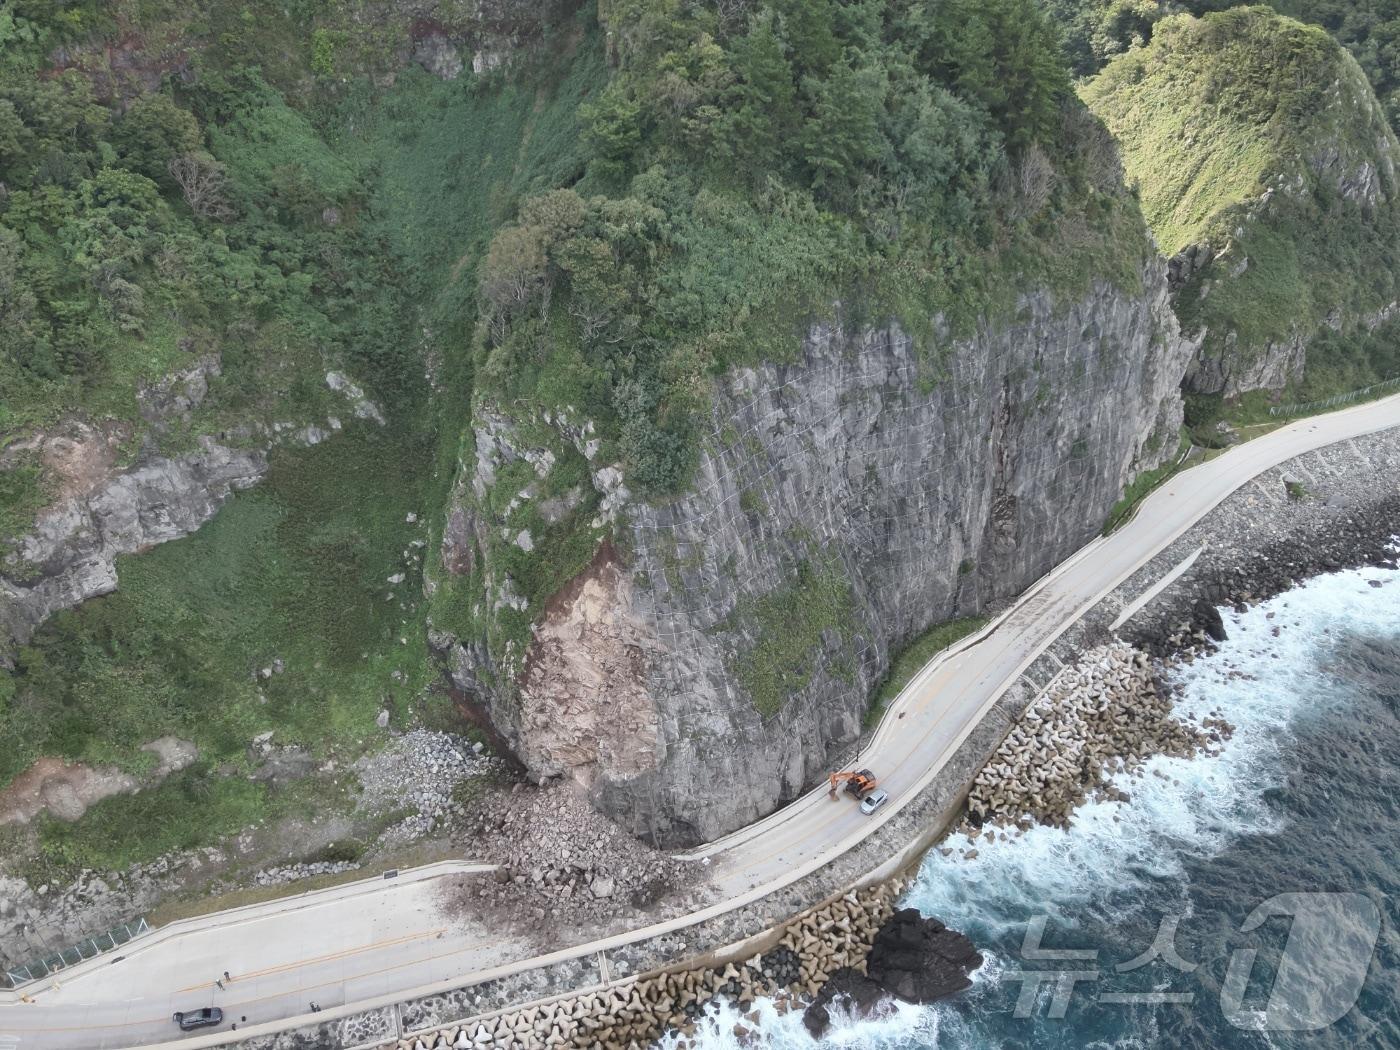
[802, 907, 981, 1039]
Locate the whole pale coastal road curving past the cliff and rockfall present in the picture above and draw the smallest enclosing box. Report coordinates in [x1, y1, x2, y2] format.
[0, 395, 1400, 1050]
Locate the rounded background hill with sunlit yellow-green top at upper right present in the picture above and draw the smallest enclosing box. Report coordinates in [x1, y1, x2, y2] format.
[1084, 7, 1400, 398]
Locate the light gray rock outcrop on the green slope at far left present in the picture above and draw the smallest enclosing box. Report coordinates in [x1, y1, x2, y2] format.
[0, 438, 267, 651]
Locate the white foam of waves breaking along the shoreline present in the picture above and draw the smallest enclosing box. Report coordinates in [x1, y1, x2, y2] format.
[672, 568, 1400, 1050]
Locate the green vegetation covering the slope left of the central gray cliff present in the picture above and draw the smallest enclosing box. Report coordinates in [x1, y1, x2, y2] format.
[0, 0, 605, 871]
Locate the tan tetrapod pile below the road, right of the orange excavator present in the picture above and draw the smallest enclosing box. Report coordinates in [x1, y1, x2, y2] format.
[958, 643, 1232, 837]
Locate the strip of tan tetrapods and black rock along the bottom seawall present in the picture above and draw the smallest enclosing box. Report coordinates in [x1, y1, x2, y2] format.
[395, 879, 957, 1050]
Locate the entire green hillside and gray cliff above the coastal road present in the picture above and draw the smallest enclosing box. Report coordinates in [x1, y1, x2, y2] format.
[0, 0, 1396, 896]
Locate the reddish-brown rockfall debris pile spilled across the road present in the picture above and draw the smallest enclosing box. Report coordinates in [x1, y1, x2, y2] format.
[451, 784, 683, 920]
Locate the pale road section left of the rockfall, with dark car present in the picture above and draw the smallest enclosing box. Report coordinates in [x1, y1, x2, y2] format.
[0, 864, 529, 1050]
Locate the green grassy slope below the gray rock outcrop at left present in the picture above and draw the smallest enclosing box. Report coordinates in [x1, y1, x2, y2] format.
[0, 424, 427, 827]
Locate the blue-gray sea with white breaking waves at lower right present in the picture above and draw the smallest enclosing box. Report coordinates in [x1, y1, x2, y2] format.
[663, 568, 1400, 1050]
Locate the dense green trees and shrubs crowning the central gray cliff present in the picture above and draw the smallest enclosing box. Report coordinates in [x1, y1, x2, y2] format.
[476, 0, 1145, 496]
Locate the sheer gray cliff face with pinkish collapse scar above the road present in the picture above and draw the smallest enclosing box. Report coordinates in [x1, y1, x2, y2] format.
[435, 259, 1191, 844]
